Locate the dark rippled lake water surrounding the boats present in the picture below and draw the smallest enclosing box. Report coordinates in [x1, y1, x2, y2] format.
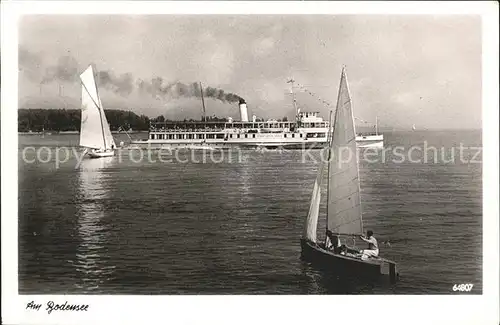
[18, 131, 482, 294]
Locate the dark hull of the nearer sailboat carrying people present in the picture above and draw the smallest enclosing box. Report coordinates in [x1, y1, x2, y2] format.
[300, 239, 399, 283]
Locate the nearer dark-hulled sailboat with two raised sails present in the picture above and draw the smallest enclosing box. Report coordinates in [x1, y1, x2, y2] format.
[301, 69, 397, 280]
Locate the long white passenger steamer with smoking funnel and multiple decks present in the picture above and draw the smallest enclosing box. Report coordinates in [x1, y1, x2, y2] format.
[131, 84, 384, 149]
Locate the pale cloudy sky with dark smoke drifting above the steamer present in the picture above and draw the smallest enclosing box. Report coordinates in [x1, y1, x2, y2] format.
[19, 15, 482, 129]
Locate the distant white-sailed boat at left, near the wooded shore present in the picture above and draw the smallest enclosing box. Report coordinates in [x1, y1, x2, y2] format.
[80, 65, 116, 158]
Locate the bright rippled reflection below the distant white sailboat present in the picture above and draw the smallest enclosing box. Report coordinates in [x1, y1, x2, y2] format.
[74, 157, 115, 292]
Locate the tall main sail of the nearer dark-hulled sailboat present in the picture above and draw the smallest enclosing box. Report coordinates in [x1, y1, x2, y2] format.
[327, 69, 363, 234]
